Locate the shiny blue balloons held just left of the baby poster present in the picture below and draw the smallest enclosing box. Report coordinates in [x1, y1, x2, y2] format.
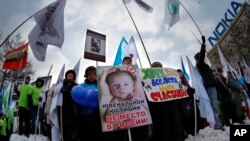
[71, 83, 99, 109]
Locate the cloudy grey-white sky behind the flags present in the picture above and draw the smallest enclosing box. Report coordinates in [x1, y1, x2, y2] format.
[0, 0, 244, 83]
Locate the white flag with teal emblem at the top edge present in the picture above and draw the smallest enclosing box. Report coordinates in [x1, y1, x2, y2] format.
[164, 0, 180, 28]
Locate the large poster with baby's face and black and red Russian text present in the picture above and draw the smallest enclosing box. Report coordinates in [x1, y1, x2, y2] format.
[97, 65, 152, 132]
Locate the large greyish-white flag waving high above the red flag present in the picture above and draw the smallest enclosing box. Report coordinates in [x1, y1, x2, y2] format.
[28, 0, 66, 61]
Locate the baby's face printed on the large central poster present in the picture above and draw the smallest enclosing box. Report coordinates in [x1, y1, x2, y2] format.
[109, 74, 134, 99]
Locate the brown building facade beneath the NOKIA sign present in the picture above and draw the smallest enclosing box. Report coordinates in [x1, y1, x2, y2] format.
[208, 3, 250, 69]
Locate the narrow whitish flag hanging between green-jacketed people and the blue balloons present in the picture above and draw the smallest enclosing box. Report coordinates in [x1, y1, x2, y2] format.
[50, 64, 65, 141]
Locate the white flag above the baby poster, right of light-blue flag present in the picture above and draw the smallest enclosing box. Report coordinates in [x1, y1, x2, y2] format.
[124, 36, 138, 65]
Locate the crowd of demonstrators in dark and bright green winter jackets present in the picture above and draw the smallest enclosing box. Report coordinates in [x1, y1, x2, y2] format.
[1, 37, 250, 141]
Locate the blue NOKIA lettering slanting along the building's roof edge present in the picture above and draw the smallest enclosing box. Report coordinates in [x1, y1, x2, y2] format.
[208, 1, 242, 47]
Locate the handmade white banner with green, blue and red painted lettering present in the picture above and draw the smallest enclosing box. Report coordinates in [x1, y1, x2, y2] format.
[140, 68, 188, 102]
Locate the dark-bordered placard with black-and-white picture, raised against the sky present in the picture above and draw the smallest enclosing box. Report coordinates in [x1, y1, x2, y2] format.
[84, 30, 106, 62]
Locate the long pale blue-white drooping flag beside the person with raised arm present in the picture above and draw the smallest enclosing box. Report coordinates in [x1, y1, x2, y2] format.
[186, 56, 215, 128]
